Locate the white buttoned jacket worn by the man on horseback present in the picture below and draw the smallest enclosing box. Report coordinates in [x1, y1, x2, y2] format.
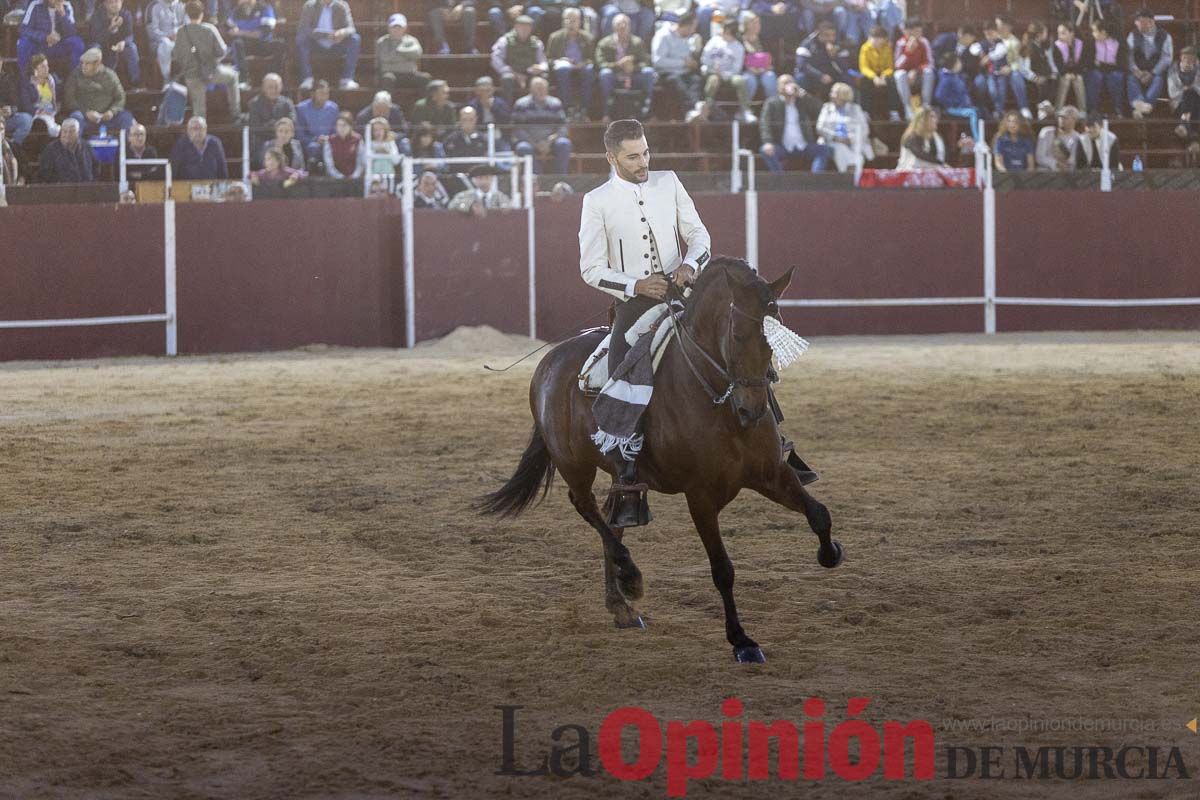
[580, 170, 712, 300]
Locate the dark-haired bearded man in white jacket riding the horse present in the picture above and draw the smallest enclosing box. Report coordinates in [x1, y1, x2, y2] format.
[580, 120, 817, 528]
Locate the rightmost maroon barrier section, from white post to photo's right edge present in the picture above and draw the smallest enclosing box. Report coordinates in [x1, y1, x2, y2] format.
[996, 191, 1200, 331]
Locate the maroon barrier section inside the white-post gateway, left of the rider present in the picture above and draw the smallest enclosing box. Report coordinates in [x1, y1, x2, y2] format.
[410, 210, 528, 344]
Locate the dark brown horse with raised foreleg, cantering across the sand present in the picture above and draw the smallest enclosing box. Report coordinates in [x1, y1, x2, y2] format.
[476, 257, 842, 663]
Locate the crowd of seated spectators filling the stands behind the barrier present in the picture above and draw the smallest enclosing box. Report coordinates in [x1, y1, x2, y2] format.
[0, 0, 1200, 191]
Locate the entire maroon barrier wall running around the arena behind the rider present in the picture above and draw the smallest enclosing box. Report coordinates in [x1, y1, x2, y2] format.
[0, 191, 1200, 360]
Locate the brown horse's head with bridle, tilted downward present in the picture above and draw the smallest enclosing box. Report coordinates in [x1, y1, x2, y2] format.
[689, 259, 796, 427]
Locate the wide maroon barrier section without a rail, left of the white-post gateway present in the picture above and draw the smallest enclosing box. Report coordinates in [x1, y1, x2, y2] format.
[175, 199, 403, 353]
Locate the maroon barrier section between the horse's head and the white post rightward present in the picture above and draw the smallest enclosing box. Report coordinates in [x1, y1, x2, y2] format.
[758, 190, 983, 336]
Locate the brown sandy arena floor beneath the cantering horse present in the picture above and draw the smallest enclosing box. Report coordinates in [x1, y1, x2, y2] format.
[0, 332, 1200, 800]
